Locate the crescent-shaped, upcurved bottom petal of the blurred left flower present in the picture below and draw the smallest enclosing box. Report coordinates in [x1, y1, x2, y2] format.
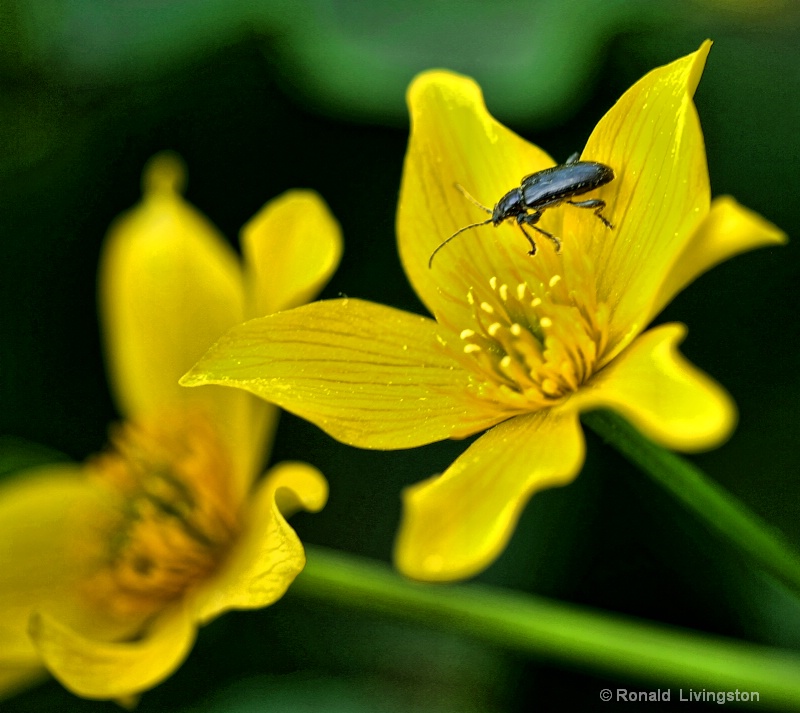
[30, 606, 196, 699]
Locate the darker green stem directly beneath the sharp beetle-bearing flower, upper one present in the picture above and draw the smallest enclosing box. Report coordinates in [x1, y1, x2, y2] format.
[582, 411, 800, 596]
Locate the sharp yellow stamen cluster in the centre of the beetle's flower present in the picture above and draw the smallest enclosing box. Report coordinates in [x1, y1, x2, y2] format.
[450, 274, 609, 412]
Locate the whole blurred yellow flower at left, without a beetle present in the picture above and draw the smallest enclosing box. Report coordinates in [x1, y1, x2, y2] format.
[0, 154, 341, 700]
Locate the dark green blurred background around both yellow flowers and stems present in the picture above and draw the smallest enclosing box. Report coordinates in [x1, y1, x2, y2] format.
[0, 0, 800, 712]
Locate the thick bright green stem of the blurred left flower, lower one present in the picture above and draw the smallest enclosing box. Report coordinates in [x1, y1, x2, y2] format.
[289, 547, 800, 710]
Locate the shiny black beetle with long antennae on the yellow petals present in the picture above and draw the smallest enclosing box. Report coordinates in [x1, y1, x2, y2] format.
[428, 153, 614, 268]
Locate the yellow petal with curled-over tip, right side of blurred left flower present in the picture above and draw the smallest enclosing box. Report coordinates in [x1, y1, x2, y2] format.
[198, 463, 328, 622]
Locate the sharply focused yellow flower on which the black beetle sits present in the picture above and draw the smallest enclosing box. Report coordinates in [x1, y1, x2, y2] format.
[183, 43, 784, 580]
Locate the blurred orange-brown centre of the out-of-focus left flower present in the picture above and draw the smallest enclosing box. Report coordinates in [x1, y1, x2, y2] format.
[87, 411, 238, 617]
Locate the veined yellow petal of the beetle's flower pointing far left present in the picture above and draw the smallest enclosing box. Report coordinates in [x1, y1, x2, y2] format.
[181, 299, 507, 449]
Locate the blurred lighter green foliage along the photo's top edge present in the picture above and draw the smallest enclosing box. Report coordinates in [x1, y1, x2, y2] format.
[6, 0, 798, 174]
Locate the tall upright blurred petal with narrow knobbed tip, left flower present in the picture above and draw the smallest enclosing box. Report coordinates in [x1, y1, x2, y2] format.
[99, 154, 257, 492]
